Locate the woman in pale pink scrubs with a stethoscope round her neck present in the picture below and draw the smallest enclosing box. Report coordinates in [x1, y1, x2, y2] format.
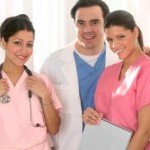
[0, 14, 61, 150]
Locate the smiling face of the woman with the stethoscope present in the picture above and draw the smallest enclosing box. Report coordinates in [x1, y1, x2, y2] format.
[2, 30, 34, 66]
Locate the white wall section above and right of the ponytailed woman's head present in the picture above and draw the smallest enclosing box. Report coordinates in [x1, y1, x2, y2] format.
[104, 0, 150, 46]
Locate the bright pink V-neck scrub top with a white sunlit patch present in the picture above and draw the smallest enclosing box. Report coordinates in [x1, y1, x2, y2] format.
[95, 55, 150, 150]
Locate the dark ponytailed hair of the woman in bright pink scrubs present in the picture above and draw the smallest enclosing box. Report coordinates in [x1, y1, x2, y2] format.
[104, 10, 144, 49]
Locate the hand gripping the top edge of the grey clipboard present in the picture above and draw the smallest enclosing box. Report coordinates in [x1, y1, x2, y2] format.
[82, 107, 103, 125]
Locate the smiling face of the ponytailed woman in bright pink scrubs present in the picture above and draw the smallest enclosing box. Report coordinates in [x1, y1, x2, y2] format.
[105, 26, 138, 60]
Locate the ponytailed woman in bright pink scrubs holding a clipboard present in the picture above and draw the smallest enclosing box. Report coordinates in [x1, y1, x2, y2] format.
[83, 10, 150, 150]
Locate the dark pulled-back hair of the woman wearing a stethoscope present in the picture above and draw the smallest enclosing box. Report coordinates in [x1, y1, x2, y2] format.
[0, 14, 35, 42]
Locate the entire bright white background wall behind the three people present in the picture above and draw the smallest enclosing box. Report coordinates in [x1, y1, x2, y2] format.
[0, 0, 150, 71]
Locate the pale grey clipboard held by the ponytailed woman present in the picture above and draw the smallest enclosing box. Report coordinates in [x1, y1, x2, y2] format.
[78, 119, 133, 150]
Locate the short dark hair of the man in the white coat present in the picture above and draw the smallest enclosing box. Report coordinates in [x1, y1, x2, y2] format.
[70, 0, 110, 20]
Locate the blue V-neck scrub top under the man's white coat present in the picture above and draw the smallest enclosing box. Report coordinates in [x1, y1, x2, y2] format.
[74, 46, 106, 112]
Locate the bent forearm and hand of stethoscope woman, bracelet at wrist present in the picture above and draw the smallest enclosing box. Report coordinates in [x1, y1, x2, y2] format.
[27, 76, 60, 135]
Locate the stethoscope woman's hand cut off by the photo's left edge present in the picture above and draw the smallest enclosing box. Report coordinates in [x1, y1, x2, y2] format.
[0, 79, 9, 96]
